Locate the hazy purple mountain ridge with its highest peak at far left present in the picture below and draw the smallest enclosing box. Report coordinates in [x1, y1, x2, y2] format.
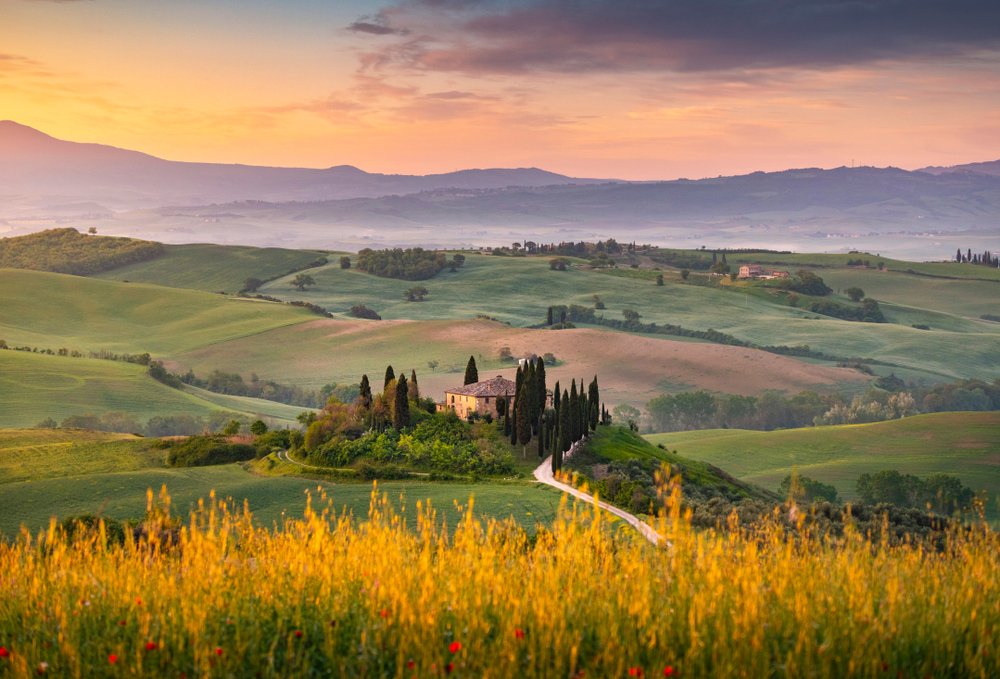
[0, 120, 597, 216]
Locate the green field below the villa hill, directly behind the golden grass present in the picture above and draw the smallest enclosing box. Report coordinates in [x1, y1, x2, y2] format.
[0, 429, 561, 537]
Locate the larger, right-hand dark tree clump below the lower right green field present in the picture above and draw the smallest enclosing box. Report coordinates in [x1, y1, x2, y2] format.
[857, 470, 976, 515]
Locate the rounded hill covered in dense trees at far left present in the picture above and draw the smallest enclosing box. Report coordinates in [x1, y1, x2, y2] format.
[0, 229, 166, 276]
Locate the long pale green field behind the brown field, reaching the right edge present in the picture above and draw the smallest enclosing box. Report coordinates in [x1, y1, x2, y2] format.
[265, 255, 1000, 380]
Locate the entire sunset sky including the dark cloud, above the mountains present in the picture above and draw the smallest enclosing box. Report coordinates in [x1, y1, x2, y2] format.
[0, 0, 1000, 179]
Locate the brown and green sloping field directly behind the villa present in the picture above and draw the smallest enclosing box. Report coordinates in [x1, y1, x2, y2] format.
[174, 320, 866, 403]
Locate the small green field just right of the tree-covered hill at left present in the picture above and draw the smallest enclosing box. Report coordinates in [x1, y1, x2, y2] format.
[94, 243, 324, 293]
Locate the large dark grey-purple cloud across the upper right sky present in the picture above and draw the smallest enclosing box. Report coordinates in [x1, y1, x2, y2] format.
[359, 0, 1000, 74]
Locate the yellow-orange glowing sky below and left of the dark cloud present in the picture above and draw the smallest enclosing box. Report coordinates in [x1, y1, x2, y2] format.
[0, 0, 1000, 179]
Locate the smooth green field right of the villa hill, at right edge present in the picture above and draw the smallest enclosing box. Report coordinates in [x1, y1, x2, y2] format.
[646, 412, 1000, 510]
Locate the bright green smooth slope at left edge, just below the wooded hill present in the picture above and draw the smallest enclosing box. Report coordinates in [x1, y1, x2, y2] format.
[0, 269, 315, 358]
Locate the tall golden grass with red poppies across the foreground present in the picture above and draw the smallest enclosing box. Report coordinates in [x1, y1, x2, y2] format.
[0, 489, 1000, 678]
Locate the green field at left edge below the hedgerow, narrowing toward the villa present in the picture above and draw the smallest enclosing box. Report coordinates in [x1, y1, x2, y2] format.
[0, 351, 304, 427]
